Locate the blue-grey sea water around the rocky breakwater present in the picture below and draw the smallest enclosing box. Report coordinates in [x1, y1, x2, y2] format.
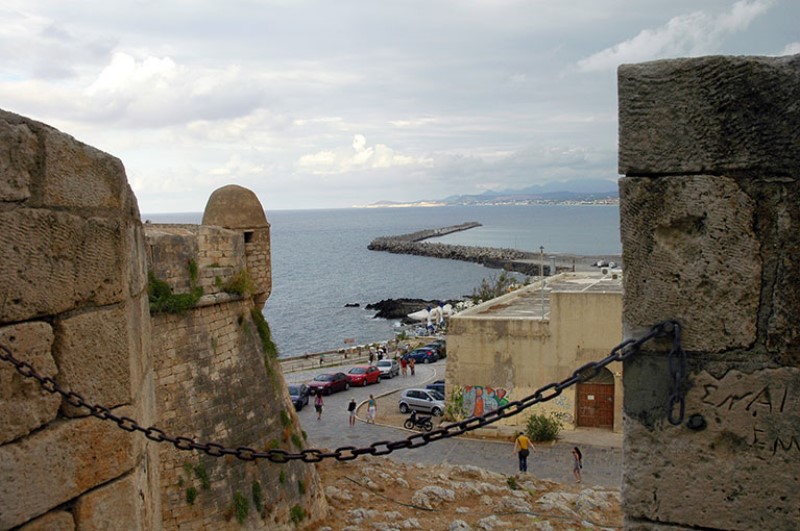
[142, 205, 621, 356]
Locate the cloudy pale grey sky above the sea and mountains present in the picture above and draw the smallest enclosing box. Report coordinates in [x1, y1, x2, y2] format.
[0, 0, 800, 213]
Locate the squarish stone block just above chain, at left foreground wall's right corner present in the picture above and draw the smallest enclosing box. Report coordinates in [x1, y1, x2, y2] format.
[53, 299, 138, 415]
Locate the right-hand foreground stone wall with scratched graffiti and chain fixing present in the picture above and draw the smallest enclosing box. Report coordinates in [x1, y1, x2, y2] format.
[619, 55, 800, 530]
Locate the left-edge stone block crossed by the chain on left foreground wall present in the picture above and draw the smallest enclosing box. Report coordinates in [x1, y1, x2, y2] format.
[0, 322, 61, 444]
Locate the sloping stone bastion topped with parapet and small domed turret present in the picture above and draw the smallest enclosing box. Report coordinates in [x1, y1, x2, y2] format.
[145, 186, 325, 529]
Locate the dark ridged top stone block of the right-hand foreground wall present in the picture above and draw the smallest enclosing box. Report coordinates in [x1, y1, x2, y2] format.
[618, 55, 800, 177]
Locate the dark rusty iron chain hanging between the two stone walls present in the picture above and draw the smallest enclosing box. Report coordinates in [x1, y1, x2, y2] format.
[0, 321, 686, 463]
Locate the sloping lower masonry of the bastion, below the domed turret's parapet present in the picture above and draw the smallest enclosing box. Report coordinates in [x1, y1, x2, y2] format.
[153, 300, 325, 529]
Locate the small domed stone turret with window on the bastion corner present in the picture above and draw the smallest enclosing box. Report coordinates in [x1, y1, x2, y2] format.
[203, 184, 272, 308]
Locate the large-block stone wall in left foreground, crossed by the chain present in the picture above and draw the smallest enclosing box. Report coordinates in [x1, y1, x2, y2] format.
[0, 111, 161, 529]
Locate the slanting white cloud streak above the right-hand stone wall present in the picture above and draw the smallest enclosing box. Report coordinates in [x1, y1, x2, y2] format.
[577, 0, 774, 72]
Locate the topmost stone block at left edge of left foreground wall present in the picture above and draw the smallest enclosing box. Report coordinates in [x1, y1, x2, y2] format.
[0, 112, 39, 201]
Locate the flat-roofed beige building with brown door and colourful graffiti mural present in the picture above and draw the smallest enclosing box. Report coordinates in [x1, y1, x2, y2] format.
[446, 271, 623, 432]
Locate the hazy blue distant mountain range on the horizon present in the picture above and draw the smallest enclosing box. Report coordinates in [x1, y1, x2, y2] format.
[367, 179, 619, 208]
